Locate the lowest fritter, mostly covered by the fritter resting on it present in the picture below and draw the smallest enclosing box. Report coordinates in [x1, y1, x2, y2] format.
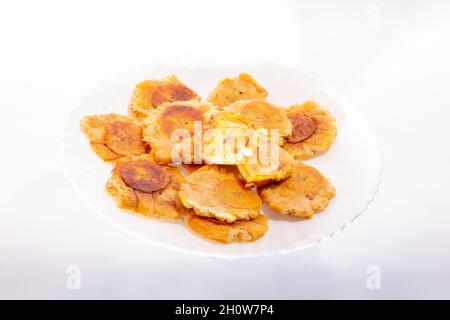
[187, 214, 269, 243]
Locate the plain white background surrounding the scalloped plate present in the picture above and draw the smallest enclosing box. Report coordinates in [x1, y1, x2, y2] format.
[0, 0, 450, 299]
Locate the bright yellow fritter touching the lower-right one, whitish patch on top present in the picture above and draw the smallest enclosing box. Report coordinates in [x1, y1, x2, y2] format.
[237, 143, 295, 188]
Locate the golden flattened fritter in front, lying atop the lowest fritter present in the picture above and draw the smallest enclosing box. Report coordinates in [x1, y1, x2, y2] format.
[179, 165, 262, 223]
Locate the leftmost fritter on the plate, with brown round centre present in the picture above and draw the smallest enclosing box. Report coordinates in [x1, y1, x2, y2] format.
[81, 113, 149, 161]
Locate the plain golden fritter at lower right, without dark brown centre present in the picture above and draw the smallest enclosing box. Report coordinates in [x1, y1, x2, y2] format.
[258, 162, 336, 218]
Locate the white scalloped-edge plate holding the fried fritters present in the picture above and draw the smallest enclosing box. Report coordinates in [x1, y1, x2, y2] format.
[62, 64, 382, 258]
